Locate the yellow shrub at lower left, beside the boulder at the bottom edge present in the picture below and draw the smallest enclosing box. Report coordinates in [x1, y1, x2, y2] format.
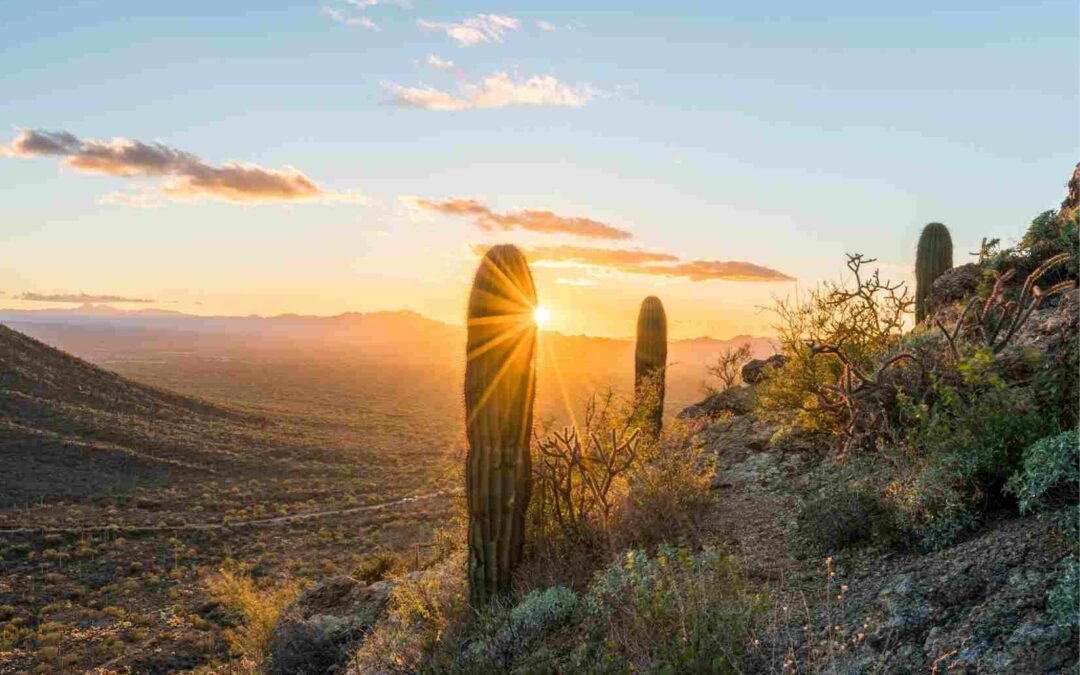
[207, 565, 300, 660]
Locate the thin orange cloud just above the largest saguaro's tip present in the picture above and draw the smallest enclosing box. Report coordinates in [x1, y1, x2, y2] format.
[409, 198, 633, 240]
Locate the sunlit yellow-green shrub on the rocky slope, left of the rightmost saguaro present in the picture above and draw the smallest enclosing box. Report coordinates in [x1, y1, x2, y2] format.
[758, 254, 914, 434]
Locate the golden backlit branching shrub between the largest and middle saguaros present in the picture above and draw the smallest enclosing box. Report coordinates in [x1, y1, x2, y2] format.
[528, 380, 711, 561]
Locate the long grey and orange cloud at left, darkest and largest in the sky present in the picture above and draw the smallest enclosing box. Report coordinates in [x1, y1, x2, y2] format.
[3, 129, 363, 204]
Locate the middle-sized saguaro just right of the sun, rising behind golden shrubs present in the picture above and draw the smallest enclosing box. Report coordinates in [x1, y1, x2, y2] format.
[634, 295, 667, 436]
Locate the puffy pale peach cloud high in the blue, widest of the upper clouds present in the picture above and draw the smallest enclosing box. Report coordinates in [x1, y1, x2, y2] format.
[384, 72, 595, 111]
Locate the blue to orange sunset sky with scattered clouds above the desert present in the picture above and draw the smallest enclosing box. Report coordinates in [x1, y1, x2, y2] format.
[0, 0, 1080, 338]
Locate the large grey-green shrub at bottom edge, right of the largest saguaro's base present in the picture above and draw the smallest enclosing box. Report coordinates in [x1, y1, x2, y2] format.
[578, 544, 764, 673]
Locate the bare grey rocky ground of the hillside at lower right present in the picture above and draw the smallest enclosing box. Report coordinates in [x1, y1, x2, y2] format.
[688, 291, 1078, 673]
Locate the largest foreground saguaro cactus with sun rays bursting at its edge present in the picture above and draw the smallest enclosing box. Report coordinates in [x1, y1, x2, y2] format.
[464, 245, 537, 607]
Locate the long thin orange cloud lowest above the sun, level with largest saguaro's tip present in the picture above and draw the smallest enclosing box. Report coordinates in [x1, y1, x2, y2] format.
[471, 244, 795, 285]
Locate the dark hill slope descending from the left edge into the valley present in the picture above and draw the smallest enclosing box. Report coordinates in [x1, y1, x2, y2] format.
[0, 326, 296, 508]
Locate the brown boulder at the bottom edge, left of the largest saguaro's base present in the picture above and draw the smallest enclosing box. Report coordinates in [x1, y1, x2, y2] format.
[270, 577, 397, 675]
